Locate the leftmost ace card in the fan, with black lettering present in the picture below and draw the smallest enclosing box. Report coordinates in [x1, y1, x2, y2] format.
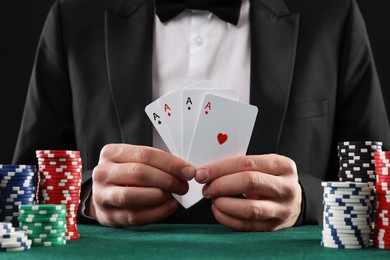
[145, 100, 178, 156]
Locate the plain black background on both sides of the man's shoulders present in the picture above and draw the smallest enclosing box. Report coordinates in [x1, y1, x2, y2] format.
[0, 0, 390, 164]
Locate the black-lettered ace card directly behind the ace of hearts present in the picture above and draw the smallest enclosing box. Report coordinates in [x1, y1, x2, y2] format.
[181, 88, 238, 159]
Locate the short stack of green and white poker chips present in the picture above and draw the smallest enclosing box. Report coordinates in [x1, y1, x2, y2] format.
[18, 204, 67, 246]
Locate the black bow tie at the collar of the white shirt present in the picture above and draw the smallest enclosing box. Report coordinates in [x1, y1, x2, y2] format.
[155, 0, 241, 25]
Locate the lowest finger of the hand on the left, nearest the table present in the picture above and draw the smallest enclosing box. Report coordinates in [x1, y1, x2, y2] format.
[97, 199, 178, 227]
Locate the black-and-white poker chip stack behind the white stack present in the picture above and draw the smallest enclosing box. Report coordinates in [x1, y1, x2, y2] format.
[337, 141, 382, 236]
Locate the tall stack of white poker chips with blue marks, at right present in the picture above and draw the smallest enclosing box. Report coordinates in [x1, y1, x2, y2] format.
[321, 182, 371, 249]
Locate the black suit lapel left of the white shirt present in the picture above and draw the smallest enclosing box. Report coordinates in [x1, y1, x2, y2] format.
[105, 0, 154, 145]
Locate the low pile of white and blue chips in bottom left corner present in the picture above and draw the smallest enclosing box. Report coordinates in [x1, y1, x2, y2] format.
[0, 222, 31, 252]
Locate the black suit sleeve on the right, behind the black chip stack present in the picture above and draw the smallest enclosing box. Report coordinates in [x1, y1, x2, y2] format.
[296, 0, 390, 225]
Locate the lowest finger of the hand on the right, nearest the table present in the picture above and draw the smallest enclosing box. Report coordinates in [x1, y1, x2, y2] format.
[211, 205, 281, 232]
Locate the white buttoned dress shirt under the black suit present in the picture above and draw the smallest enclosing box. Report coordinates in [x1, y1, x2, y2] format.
[153, 0, 251, 151]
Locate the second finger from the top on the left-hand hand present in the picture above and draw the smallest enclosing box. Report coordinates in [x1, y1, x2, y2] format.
[93, 163, 188, 195]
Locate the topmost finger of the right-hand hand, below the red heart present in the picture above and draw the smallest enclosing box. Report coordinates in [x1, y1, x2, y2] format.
[195, 154, 296, 183]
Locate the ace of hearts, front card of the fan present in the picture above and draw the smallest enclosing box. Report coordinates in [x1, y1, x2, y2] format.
[188, 94, 258, 166]
